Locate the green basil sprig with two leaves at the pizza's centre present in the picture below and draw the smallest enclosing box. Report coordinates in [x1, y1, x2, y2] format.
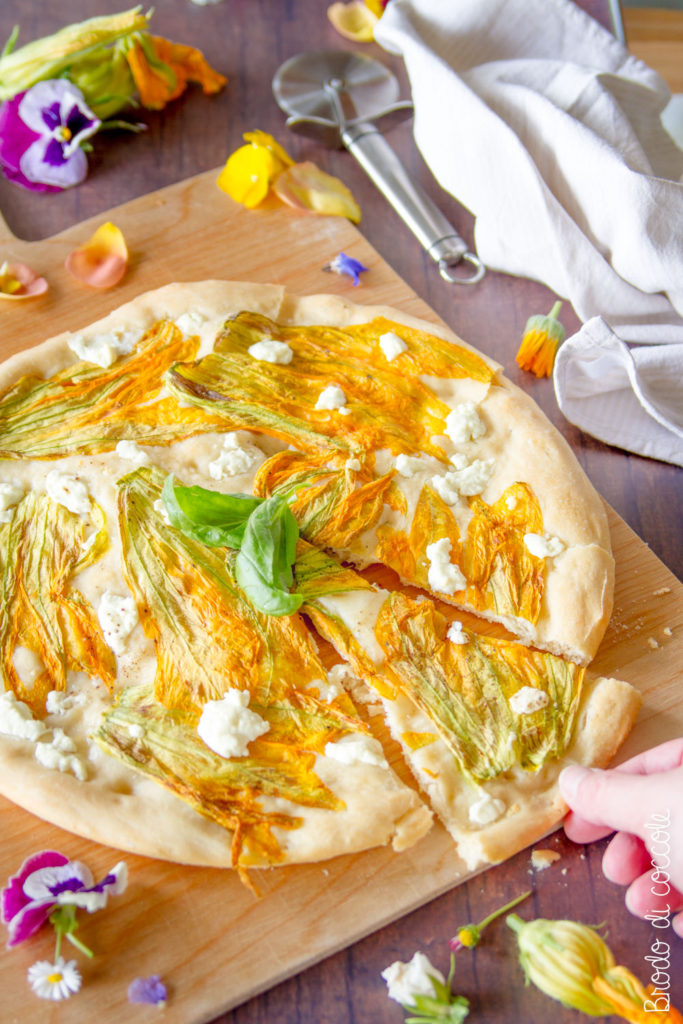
[162, 475, 303, 615]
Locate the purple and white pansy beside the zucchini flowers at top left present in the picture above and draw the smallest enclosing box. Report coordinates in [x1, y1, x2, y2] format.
[0, 79, 100, 191]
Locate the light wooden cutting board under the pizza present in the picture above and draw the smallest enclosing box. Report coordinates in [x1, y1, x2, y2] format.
[0, 173, 683, 1024]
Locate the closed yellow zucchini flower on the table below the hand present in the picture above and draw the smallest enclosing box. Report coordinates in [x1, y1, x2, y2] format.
[506, 913, 683, 1024]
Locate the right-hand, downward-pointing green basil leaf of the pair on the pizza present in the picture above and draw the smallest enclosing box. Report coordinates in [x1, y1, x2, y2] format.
[236, 495, 303, 615]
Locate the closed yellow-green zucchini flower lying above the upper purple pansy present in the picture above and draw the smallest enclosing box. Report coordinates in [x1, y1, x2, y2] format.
[0, 7, 147, 101]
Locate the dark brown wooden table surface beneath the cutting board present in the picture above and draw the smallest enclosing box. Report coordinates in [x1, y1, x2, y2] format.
[0, 0, 683, 1024]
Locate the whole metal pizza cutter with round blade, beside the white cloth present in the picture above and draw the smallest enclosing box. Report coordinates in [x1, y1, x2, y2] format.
[272, 50, 485, 285]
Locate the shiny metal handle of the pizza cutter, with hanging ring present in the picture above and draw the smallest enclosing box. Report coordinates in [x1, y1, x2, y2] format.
[324, 78, 485, 285]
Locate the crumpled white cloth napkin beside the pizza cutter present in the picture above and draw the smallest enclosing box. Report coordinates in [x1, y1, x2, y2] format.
[375, 0, 683, 465]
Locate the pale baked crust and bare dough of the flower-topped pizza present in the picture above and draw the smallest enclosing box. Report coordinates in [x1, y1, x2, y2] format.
[0, 282, 638, 866]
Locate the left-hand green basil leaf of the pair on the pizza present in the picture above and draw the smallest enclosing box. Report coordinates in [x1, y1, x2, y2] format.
[162, 474, 262, 548]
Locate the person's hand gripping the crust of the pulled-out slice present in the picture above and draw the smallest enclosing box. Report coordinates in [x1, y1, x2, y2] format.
[559, 737, 683, 938]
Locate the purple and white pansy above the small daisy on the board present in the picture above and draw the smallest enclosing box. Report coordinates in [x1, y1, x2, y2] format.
[2, 850, 128, 946]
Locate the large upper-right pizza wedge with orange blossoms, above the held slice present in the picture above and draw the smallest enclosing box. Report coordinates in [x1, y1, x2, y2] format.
[167, 297, 613, 664]
